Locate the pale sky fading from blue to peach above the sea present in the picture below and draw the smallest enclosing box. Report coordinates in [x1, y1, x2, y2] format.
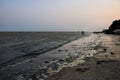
[0, 0, 120, 31]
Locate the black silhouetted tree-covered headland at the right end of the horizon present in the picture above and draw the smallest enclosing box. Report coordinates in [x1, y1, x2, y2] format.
[104, 20, 120, 34]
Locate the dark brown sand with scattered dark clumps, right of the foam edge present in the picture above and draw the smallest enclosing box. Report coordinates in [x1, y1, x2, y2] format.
[48, 34, 120, 80]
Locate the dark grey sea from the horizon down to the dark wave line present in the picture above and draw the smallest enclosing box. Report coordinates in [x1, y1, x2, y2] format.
[0, 32, 85, 64]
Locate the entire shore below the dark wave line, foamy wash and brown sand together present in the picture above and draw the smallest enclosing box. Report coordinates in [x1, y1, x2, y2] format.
[0, 33, 120, 80]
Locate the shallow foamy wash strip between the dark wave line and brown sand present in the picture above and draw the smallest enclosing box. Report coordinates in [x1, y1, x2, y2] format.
[0, 34, 98, 80]
